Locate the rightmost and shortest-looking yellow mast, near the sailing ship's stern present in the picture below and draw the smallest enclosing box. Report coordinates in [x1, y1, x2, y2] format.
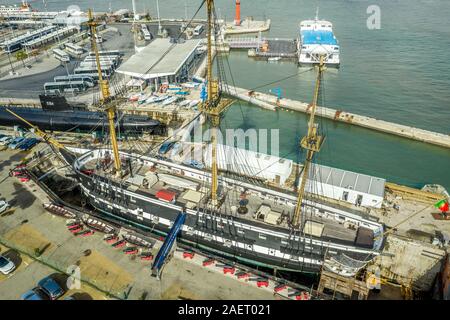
[292, 56, 325, 228]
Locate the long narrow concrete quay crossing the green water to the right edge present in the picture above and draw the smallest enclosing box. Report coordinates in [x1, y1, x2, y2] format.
[230, 88, 450, 148]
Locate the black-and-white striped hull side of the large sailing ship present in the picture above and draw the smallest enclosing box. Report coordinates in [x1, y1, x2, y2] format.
[78, 173, 378, 273]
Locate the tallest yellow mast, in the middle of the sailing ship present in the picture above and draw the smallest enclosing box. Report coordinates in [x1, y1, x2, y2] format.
[200, 0, 232, 206]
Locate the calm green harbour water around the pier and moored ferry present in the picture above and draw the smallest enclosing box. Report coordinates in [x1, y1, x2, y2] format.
[7, 0, 450, 190]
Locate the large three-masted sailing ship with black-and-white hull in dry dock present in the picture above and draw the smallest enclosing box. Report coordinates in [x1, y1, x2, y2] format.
[9, 0, 383, 275]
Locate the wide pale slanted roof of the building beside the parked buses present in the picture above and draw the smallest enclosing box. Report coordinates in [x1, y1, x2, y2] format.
[117, 38, 200, 79]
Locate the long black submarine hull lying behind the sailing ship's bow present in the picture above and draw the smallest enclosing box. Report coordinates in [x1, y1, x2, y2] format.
[0, 107, 164, 134]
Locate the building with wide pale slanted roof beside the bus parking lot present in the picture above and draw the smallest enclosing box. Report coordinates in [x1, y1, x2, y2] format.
[117, 38, 200, 89]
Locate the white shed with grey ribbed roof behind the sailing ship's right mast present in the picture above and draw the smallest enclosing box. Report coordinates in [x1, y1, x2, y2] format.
[299, 164, 386, 208]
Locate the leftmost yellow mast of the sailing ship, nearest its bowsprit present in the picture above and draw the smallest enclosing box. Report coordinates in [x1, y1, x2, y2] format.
[88, 9, 122, 176]
